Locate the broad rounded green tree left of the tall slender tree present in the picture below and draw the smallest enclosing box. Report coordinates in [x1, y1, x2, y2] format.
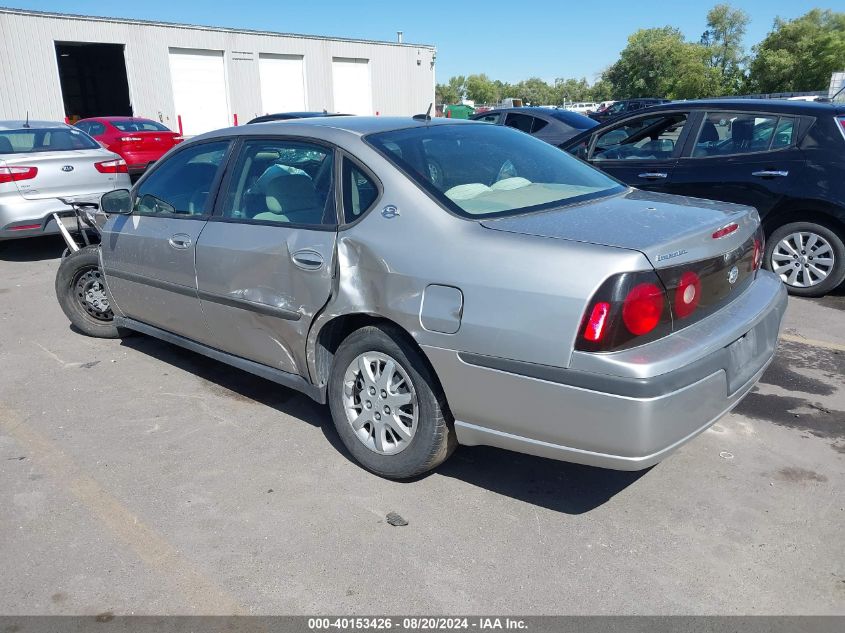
[602, 26, 719, 99]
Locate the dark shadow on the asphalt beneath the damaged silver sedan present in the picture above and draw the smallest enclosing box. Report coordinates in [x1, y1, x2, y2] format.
[122, 335, 649, 515]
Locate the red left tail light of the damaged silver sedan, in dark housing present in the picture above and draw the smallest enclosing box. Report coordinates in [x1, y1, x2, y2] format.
[575, 271, 672, 352]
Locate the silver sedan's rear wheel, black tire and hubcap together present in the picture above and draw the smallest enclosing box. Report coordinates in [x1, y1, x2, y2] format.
[328, 325, 457, 479]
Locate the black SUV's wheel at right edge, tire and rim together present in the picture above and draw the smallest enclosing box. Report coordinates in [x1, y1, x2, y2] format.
[765, 222, 845, 297]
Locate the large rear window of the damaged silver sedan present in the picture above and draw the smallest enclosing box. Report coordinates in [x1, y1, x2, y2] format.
[366, 123, 625, 218]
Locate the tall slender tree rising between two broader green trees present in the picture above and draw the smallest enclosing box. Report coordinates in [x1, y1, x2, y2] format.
[701, 4, 751, 94]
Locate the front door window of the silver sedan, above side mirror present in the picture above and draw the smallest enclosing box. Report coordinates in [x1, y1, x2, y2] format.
[135, 141, 229, 215]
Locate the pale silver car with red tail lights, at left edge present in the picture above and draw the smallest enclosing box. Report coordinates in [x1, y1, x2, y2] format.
[0, 121, 130, 240]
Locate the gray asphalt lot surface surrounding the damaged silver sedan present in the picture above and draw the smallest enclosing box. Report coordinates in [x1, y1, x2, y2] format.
[0, 239, 845, 615]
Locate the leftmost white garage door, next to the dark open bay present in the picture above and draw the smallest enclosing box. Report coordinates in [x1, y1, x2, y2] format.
[170, 48, 232, 136]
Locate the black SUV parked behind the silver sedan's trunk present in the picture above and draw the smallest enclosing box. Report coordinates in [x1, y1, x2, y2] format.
[560, 99, 845, 297]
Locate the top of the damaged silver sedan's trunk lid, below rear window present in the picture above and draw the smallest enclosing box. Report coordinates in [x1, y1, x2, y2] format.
[481, 189, 760, 272]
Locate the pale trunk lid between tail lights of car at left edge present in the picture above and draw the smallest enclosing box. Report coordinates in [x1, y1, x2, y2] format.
[3, 149, 123, 200]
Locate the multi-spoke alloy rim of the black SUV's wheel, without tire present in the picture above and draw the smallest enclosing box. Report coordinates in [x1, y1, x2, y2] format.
[771, 231, 836, 288]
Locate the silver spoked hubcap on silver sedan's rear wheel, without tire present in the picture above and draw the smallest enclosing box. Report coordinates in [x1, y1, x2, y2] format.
[343, 352, 419, 455]
